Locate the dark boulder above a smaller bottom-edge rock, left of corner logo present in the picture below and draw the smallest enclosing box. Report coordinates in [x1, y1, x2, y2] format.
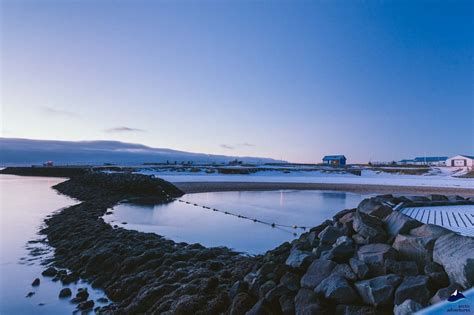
[394, 276, 431, 305]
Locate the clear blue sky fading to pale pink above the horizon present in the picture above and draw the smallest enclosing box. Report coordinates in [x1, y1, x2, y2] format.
[0, 0, 474, 163]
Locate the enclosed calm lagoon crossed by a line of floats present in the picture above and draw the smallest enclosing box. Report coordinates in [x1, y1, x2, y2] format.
[104, 190, 365, 254]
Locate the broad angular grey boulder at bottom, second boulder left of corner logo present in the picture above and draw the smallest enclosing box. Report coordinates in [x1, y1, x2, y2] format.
[354, 274, 401, 306]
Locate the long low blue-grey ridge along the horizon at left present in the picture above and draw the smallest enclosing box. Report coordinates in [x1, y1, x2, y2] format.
[0, 138, 282, 166]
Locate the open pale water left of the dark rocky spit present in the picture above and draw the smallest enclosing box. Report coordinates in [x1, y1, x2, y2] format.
[0, 175, 107, 315]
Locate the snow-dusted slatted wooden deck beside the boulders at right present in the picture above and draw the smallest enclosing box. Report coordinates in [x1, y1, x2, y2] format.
[400, 205, 474, 236]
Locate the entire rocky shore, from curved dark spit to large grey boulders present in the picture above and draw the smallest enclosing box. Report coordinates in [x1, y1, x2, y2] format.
[1, 173, 474, 315]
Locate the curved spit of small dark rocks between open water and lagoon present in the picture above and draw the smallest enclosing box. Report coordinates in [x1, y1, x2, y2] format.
[41, 172, 253, 314]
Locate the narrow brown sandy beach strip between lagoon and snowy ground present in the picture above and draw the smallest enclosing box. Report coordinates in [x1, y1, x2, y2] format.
[172, 182, 474, 197]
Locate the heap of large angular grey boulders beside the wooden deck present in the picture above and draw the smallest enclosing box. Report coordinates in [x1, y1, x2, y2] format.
[228, 195, 474, 315]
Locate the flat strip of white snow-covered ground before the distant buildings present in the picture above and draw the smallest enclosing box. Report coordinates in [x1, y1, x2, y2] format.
[138, 169, 474, 189]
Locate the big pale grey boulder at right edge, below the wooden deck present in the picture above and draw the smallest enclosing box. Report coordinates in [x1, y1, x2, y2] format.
[433, 234, 474, 289]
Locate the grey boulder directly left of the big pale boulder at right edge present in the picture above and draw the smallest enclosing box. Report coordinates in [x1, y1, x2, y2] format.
[393, 234, 433, 270]
